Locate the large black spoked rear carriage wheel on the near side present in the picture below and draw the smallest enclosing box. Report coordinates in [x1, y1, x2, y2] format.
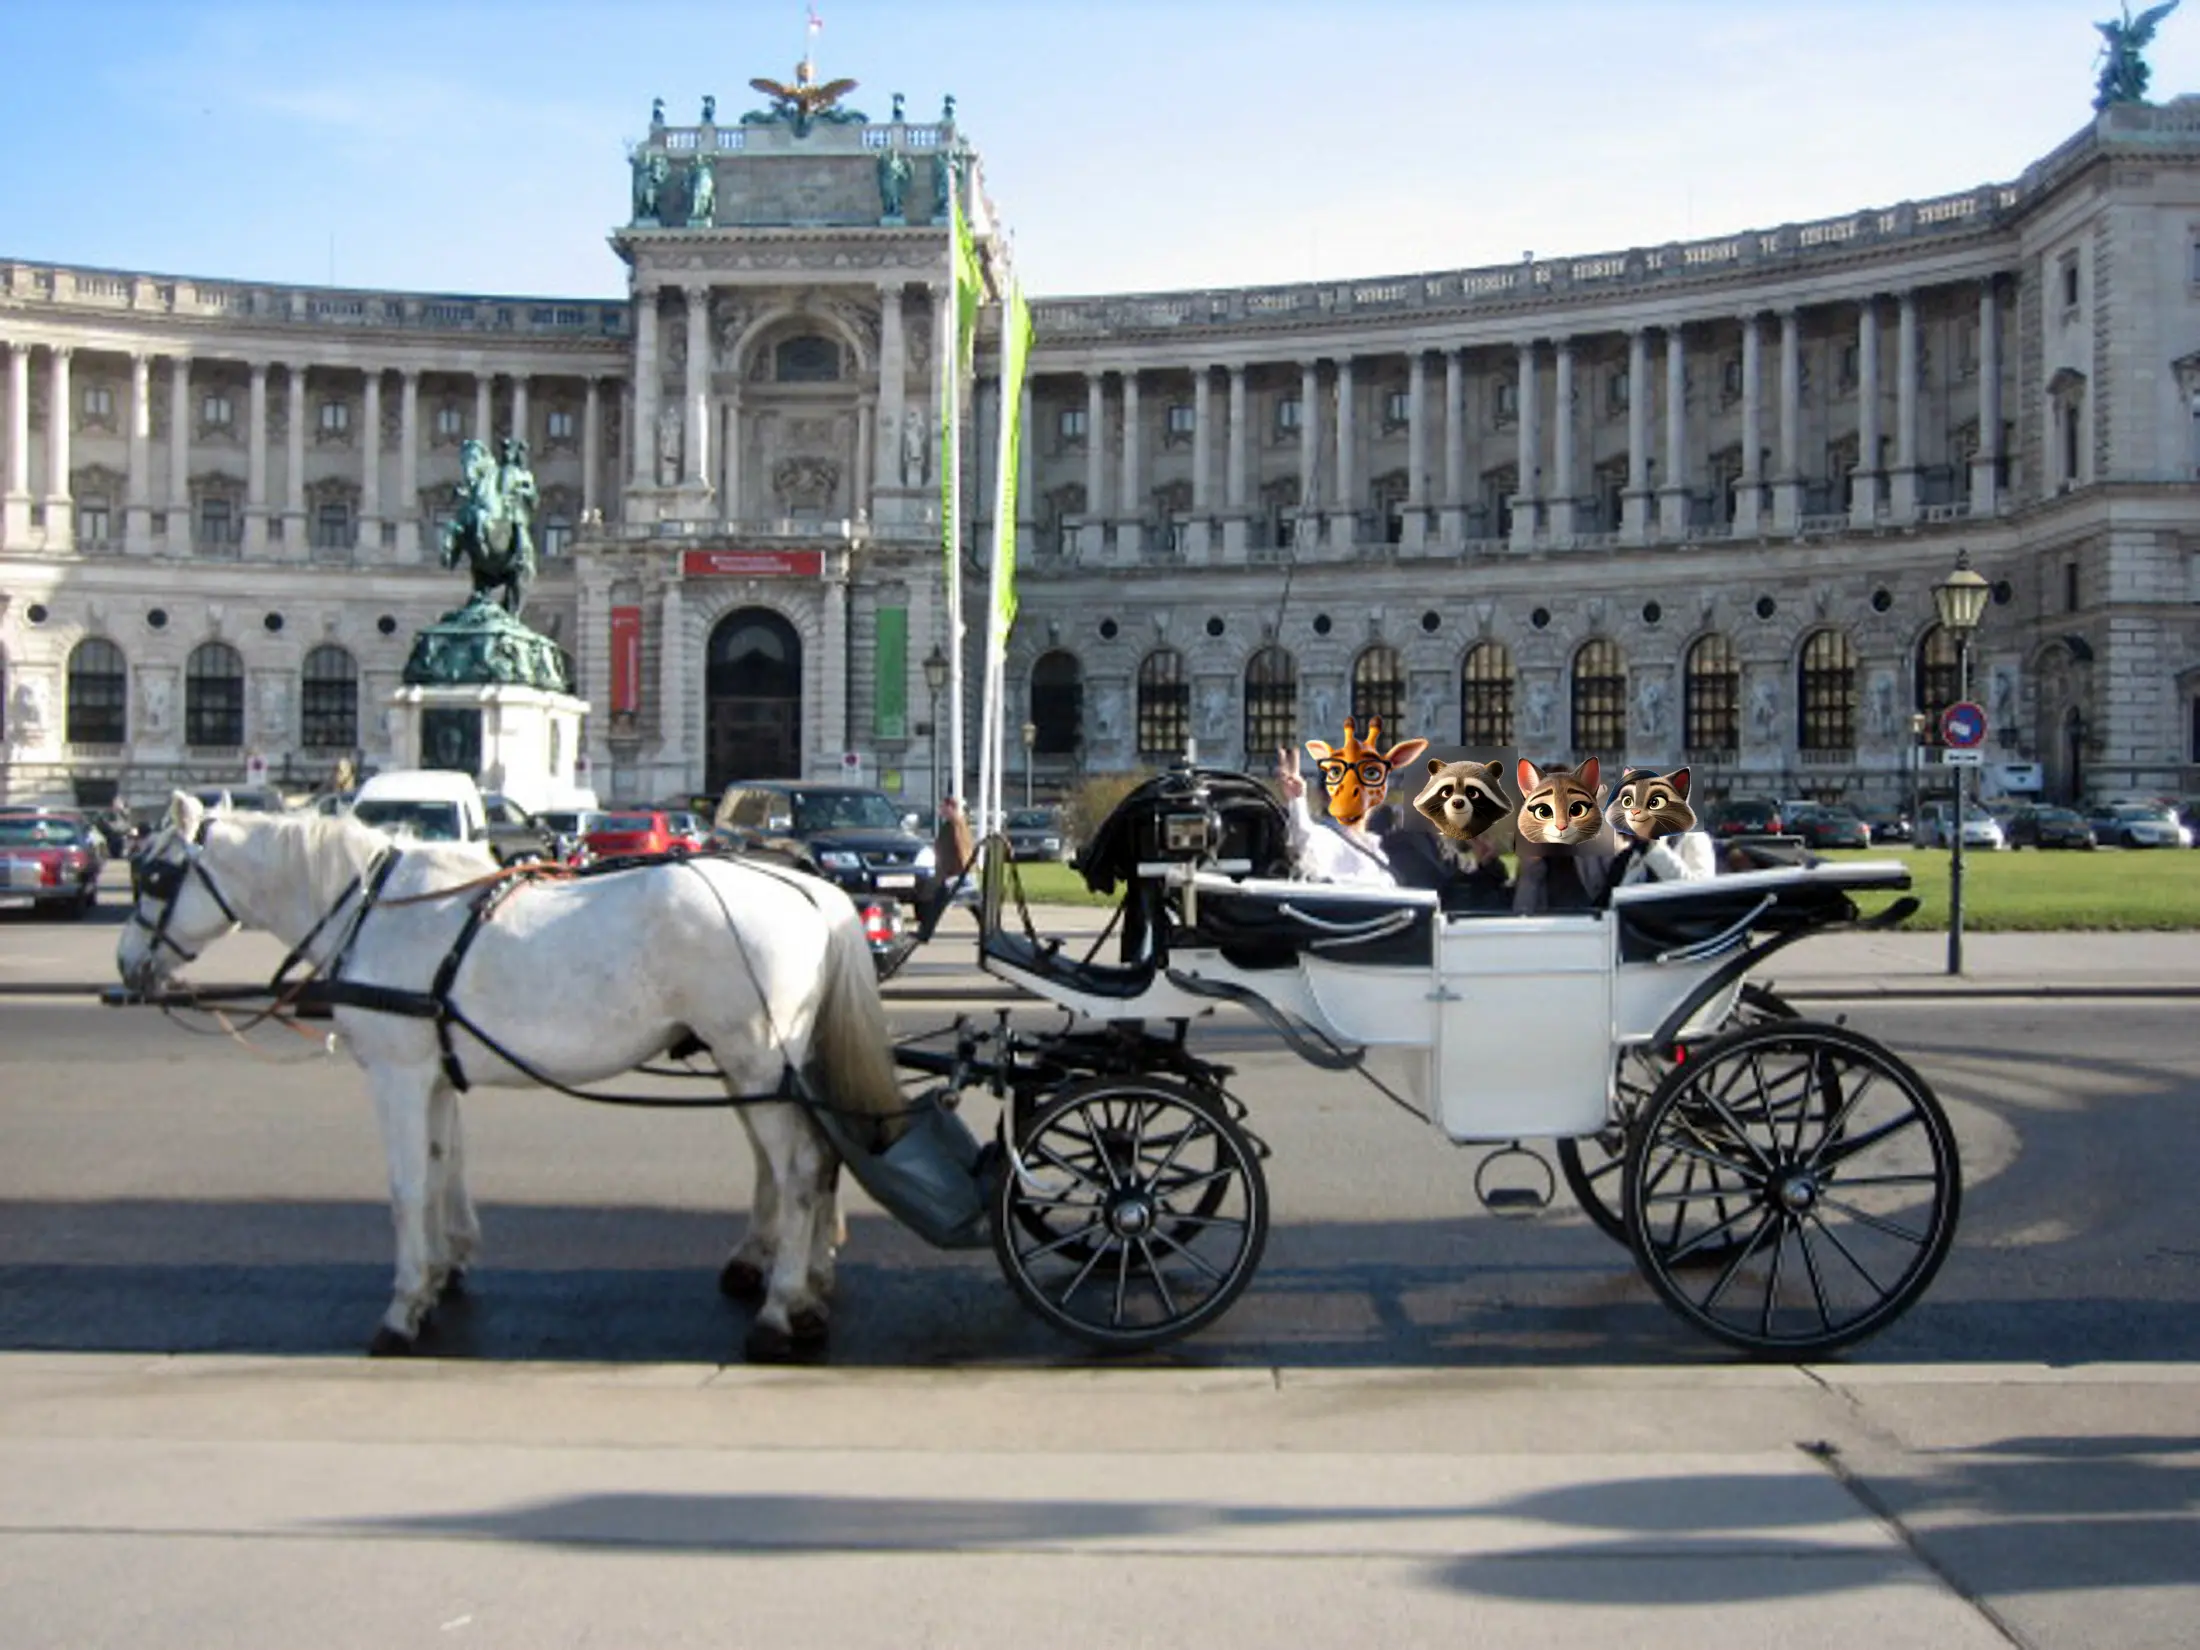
[1624, 1021, 1962, 1357]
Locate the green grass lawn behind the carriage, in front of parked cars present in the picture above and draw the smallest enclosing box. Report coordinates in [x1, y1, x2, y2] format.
[1016, 847, 2200, 933]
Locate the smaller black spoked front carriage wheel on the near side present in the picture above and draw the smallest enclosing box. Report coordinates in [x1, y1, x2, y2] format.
[992, 1078, 1267, 1353]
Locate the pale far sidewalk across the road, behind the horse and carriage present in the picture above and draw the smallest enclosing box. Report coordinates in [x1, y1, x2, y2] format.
[17, 891, 2200, 1003]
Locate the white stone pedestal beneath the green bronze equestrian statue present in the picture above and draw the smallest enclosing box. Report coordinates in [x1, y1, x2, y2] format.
[389, 684, 587, 812]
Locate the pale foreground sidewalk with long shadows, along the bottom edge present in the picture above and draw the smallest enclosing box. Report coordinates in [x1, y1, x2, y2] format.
[0, 1353, 2200, 1650]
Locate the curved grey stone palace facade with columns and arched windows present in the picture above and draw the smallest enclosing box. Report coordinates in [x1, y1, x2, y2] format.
[0, 85, 2200, 801]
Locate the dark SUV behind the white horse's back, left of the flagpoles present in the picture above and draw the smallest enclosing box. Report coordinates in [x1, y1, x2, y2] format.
[711, 779, 937, 957]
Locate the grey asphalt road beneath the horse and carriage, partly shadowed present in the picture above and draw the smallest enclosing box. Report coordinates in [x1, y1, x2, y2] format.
[0, 999, 2200, 1366]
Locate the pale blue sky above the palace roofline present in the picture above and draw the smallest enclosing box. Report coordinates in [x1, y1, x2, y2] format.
[0, 0, 2200, 295]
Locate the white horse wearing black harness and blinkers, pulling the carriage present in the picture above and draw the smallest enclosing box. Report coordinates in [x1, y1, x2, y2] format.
[114, 792, 904, 1360]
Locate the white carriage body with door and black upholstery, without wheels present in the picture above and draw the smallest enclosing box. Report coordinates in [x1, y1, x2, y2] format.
[986, 860, 1907, 1142]
